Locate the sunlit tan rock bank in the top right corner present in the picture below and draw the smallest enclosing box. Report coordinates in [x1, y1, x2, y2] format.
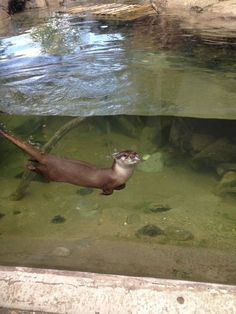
[151, 0, 236, 44]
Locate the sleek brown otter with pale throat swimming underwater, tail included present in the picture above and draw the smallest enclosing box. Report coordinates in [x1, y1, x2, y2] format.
[0, 128, 139, 195]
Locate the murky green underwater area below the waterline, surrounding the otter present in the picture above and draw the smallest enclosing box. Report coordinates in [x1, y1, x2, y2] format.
[0, 115, 236, 284]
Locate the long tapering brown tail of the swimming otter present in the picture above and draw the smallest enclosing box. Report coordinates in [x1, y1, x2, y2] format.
[0, 128, 43, 162]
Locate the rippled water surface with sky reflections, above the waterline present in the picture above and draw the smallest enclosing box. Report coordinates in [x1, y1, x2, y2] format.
[0, 10, 236, 118]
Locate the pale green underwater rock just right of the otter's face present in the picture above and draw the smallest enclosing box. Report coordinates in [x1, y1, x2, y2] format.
[137, 152, 164, 172]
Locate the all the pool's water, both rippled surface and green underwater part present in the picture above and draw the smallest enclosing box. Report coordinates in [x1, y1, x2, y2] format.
[0, 5, 236, 284]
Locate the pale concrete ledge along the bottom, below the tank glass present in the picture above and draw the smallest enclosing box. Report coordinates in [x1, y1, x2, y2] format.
[0, 267, 236, 314]
